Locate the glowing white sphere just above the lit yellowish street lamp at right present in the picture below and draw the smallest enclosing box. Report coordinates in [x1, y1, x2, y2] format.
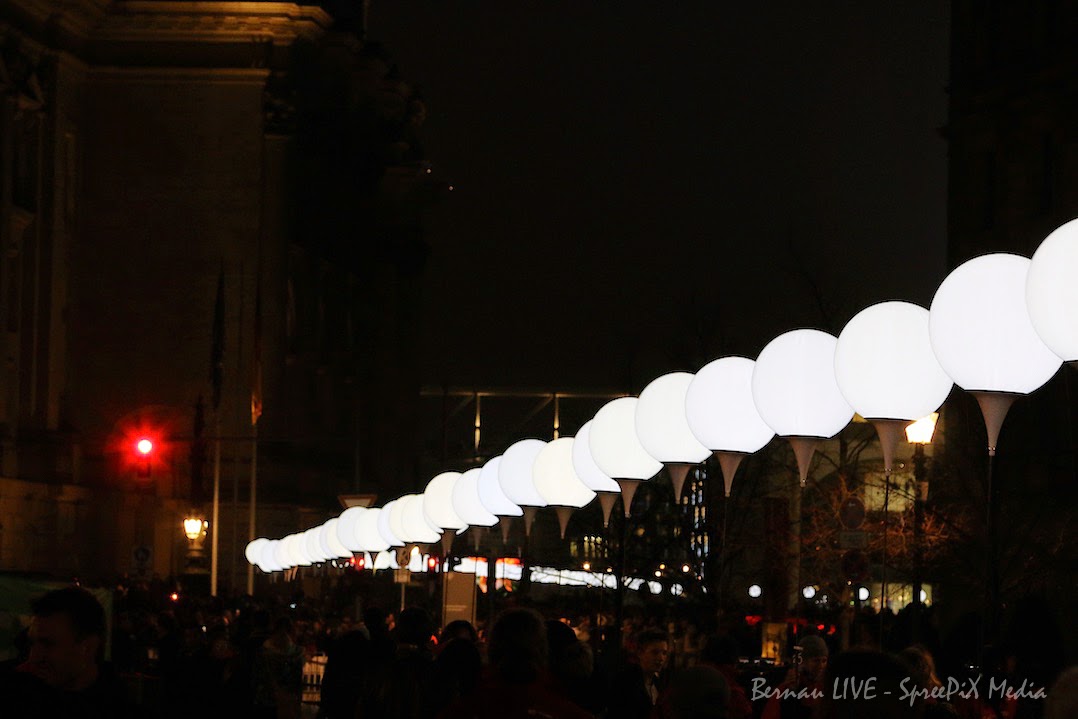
[834, 302, 952, 420]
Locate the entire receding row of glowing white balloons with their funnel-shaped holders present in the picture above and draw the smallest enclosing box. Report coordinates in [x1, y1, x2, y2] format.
[246, 215, 1078, 571]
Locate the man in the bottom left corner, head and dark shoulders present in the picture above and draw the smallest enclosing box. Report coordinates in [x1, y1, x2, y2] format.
[0, 586, 129, 719]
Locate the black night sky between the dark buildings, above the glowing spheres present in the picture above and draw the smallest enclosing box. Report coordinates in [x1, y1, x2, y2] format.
[370, 0, 949, 391]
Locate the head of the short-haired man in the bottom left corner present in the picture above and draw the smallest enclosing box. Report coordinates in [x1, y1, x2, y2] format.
[29, 586, 105, 690]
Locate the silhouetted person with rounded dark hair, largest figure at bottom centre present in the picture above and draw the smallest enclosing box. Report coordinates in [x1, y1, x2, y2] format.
[442, 609, 590, 719]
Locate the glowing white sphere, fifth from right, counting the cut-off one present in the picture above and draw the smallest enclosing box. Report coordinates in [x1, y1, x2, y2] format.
[685, 357, 775, 454]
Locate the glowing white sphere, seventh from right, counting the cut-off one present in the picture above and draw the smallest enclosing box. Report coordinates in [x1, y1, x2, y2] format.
[588, 397, 663, 480]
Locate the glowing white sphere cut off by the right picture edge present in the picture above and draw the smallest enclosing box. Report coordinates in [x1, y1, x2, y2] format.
[1025, 220, 1078, 362]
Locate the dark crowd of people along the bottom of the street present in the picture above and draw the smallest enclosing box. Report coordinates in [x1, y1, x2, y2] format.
[0, 586, 1078, 719]
